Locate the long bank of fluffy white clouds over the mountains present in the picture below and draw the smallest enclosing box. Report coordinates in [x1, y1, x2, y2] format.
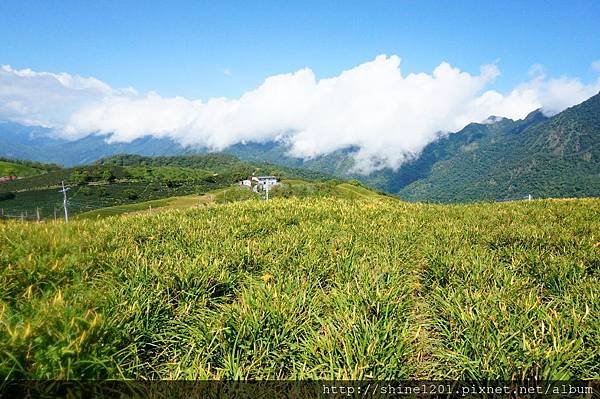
[0, 55, 600, 171]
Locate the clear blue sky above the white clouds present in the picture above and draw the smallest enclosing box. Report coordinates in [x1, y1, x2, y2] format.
[0, 0, 600, 99]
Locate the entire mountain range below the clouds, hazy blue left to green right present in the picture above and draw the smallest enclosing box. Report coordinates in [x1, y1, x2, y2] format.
[0, 94, 600, 202]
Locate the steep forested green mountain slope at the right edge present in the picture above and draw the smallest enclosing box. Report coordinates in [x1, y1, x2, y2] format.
[399, 95, 600, 202]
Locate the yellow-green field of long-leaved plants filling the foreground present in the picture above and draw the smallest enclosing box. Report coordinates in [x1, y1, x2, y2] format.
[0, 198, 600, 380]
